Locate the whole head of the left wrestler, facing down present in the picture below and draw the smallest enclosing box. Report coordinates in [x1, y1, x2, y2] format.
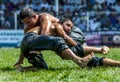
[20, 8, 38, 27]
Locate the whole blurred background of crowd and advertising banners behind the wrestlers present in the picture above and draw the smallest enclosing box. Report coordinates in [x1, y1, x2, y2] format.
[0, 0, 120, 47]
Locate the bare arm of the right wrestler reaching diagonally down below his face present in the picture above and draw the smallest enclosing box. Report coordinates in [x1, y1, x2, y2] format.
[54, 23, 77, 46]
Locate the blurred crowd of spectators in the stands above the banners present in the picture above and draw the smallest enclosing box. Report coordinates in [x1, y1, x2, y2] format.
[0, 0, 120, 31]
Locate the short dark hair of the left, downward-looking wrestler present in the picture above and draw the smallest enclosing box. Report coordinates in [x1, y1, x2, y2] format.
[19, 8, 36, 19]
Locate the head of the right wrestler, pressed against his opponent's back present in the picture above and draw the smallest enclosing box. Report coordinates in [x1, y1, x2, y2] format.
[60, 18, 73, 33]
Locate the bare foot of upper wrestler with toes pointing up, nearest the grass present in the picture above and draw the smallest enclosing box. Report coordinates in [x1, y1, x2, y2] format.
[78, 52, 94, 68]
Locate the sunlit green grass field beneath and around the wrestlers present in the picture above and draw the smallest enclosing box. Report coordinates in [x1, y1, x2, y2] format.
[0, 48, 120, 82]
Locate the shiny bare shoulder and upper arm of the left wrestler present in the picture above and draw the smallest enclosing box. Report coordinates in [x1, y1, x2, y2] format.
[40, 14, 59, 35]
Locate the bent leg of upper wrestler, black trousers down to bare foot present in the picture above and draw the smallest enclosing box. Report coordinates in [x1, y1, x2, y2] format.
[33, 35, 92, 67]
